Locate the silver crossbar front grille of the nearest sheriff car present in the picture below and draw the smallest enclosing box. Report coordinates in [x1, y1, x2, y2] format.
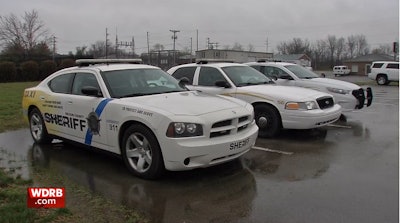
[210, 116, 252, 138]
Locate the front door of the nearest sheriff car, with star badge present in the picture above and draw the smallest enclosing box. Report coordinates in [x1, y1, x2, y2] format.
[64, 72, 110, 146]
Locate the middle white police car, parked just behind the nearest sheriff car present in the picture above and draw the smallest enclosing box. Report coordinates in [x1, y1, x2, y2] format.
[168, 61, 341, 137]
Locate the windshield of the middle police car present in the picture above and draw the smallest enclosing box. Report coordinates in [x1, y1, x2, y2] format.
[222, 66, 274, 87]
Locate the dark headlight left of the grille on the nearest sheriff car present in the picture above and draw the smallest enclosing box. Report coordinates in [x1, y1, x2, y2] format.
[166, 122, 203, 138]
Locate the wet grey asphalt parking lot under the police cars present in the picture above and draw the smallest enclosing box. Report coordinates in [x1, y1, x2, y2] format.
[0, 82, 399, 223]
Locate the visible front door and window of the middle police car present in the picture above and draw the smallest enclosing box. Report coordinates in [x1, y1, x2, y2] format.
[191, 66, 236, 96]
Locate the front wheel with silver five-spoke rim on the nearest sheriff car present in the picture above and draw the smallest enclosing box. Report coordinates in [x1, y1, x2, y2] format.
[121, 124, 165, 179]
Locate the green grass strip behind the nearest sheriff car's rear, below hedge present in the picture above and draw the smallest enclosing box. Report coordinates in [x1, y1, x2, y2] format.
[0, 82, 38, 132]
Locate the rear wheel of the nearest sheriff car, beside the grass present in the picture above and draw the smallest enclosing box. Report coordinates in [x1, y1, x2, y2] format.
[29, 108, 53, 144]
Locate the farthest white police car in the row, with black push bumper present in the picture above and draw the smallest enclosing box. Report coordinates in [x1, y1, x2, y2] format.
[246, 61, 372, 112]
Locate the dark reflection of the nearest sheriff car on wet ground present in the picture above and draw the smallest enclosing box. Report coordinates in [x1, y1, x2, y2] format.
[32, 144, 256, 222]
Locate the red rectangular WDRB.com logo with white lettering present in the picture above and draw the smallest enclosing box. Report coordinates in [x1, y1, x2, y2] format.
[27, 187, 65, 208]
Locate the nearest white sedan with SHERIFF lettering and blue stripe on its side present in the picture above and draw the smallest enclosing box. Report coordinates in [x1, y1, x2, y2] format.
[22, 60, 258, 179]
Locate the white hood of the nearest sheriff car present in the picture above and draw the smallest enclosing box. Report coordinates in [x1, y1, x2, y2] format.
[122, 91, 248, 116]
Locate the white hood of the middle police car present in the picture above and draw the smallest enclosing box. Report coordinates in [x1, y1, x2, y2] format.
[241, 84, 330, 102]
